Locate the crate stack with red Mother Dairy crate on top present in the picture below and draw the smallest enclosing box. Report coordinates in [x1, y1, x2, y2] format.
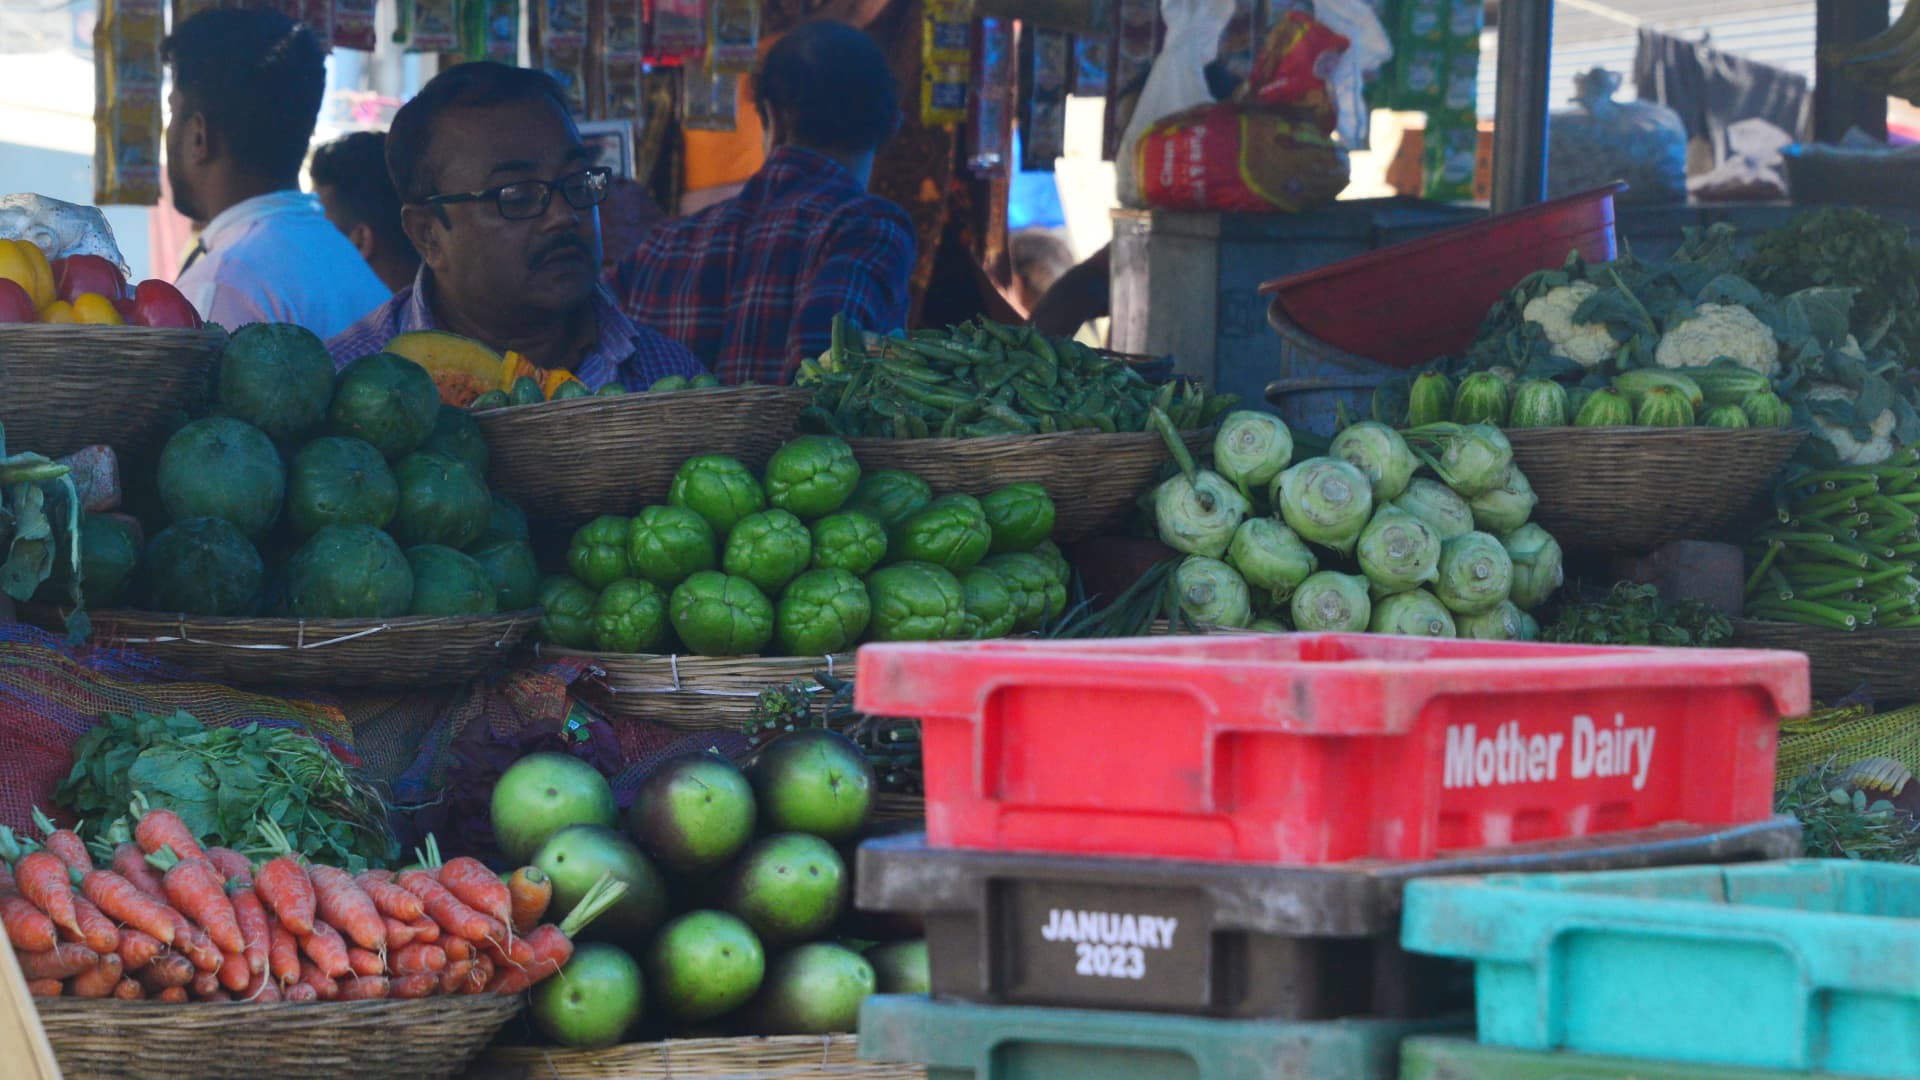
[854, 634, 1807, 1080]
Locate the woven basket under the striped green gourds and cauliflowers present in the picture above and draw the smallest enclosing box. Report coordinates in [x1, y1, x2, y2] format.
[1507, 427, 1807, 553]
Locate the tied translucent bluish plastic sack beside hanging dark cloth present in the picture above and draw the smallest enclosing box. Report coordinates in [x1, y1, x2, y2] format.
[1548, 67, 1686, 202]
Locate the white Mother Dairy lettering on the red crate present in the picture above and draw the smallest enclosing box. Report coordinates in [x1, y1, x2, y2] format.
[1440, 713, 1659, 792]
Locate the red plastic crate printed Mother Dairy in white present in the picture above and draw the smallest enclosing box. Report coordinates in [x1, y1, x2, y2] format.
[854, 634, 1807, 863]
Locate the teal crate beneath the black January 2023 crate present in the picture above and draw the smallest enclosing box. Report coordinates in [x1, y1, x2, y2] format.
[860, 995, 1465, 1080]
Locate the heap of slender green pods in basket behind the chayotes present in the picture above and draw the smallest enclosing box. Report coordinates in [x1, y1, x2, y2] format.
[799, 317, 1236, 438]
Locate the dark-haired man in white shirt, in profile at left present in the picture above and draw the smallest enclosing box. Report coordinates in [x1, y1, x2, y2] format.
[167, 8, 392, 340]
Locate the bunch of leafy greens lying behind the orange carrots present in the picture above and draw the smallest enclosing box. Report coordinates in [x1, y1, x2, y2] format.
[54, 713, 399, 871]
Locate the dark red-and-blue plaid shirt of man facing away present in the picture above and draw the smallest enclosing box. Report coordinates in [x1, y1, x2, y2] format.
[609, 146, 914, 384]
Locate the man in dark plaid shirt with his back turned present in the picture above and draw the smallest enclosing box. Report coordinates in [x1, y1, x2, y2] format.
[611, 21, 914, 384]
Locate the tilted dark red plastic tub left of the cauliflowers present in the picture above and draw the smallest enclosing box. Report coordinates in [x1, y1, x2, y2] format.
[1260, 184, 1626, 369]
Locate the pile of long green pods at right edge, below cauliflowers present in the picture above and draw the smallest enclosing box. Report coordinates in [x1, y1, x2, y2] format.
[1747, 448, 1920, 630]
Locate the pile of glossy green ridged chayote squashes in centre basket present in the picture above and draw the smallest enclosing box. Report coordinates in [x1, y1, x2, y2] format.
[538, 434, 1071, 655]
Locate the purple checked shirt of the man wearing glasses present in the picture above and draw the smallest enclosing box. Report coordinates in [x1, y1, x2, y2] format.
[326, 265, 707, 390]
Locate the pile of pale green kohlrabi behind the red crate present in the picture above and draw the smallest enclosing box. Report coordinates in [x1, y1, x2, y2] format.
[1154, 411, 1563, 640]
